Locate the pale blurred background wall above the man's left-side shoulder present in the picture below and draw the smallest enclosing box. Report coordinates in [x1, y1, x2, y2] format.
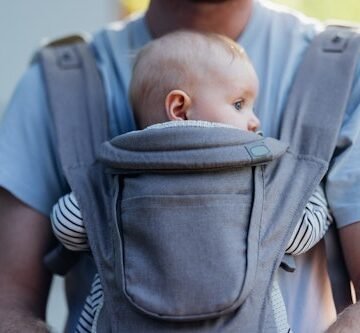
[0, 0, 119, 114]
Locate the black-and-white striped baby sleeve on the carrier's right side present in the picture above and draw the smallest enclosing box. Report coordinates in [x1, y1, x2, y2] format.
[286, 186, 333, 255]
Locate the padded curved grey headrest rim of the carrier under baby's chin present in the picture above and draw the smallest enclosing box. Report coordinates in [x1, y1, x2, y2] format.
[98, 121, 287, 173]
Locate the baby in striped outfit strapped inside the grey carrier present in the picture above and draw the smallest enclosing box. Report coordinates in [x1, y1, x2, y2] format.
[51, 31, 331, 332]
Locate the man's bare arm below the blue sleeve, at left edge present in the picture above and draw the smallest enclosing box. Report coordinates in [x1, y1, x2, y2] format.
[0, 188, 51, 333]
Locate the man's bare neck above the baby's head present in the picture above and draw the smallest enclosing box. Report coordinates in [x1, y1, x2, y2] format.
[146, 0, 253, 39]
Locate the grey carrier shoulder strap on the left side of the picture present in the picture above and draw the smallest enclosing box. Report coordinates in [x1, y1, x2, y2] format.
[40, 43, 108, 170]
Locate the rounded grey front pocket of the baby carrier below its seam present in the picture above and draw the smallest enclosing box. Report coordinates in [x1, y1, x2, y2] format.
[118, 194, 257, 320]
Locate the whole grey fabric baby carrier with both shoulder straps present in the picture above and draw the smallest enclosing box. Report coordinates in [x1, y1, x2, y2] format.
[41, 24, 360, 333]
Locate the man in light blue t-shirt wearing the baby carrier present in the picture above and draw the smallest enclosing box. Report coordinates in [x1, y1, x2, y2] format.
[0, 0, 360, 332]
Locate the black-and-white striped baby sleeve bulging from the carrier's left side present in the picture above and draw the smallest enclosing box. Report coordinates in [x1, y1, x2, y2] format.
[50, 193, 89, 251]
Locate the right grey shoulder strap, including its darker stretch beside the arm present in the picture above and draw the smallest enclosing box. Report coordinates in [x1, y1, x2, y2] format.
[280, 26, 360, 312]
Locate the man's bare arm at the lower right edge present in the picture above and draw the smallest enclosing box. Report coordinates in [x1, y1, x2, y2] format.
[327, 222, 360, 333]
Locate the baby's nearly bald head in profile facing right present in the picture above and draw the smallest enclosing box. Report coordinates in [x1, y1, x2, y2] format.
[130, 31, 259, 131]
